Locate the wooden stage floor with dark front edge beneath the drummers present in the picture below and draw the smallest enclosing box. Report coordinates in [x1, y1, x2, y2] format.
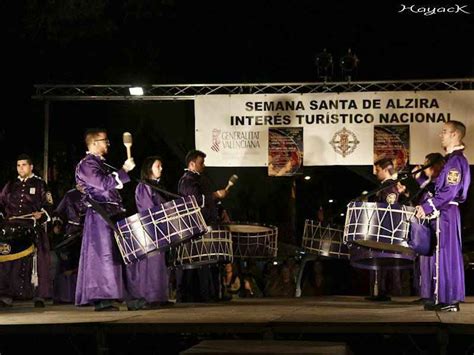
[0, 296, 474, 355]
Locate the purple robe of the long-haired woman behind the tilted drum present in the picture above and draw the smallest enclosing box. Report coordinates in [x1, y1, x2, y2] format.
[126, 183, 168, 303]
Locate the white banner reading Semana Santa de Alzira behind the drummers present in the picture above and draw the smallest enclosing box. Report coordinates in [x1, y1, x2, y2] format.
[195, 91, 474, 167]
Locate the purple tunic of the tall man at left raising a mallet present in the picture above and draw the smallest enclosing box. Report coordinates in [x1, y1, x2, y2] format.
[76, 154, 130, 305]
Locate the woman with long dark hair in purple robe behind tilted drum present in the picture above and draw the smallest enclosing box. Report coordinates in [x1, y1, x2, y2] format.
[126, 156, 169, 309]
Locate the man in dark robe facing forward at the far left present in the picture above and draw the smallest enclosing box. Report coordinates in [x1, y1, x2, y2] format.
[0, 154, 53, 307]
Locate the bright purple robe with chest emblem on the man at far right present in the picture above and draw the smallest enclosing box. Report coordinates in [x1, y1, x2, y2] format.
[421, 149, 471, 304]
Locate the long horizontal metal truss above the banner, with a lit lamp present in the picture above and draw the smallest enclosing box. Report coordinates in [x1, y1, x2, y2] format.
[32, 78, 474, 101]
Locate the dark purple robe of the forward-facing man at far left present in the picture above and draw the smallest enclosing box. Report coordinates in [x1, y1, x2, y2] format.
[0, 175, 52, 299]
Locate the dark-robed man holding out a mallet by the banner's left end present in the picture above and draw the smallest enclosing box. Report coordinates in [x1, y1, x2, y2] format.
[176, 150, 228, 302]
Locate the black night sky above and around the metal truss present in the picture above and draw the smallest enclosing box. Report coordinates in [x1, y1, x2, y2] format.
[0, 0, 474, 242]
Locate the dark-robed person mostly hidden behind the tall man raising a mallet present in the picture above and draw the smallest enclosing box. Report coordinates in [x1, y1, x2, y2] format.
[52, 186, 86, 303]
